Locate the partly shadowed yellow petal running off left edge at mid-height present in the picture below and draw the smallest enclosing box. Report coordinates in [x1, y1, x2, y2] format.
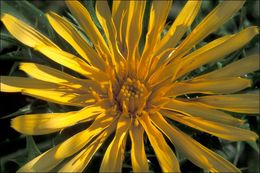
[0, 76, 96, 106]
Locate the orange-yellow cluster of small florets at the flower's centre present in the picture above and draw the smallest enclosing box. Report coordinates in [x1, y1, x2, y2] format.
[117, 78, 148, 115]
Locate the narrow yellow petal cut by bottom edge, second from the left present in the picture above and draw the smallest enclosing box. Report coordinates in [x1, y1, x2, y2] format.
[59, 123, 116, 172]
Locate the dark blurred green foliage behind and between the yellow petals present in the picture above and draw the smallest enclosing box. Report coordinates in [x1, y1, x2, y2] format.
[0, 0, 260, 173]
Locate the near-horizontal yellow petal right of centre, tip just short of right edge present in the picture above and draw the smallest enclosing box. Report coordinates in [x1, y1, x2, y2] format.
[166, 77, 251, 97]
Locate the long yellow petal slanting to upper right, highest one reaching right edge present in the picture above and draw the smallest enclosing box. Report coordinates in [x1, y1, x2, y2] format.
[176, 26, 259, 78]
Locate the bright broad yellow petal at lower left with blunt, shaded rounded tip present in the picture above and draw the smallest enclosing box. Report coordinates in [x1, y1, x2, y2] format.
[11, 106, 104, 135]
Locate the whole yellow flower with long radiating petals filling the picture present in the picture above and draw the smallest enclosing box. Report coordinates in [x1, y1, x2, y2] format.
[1, 0, 259, 172]
